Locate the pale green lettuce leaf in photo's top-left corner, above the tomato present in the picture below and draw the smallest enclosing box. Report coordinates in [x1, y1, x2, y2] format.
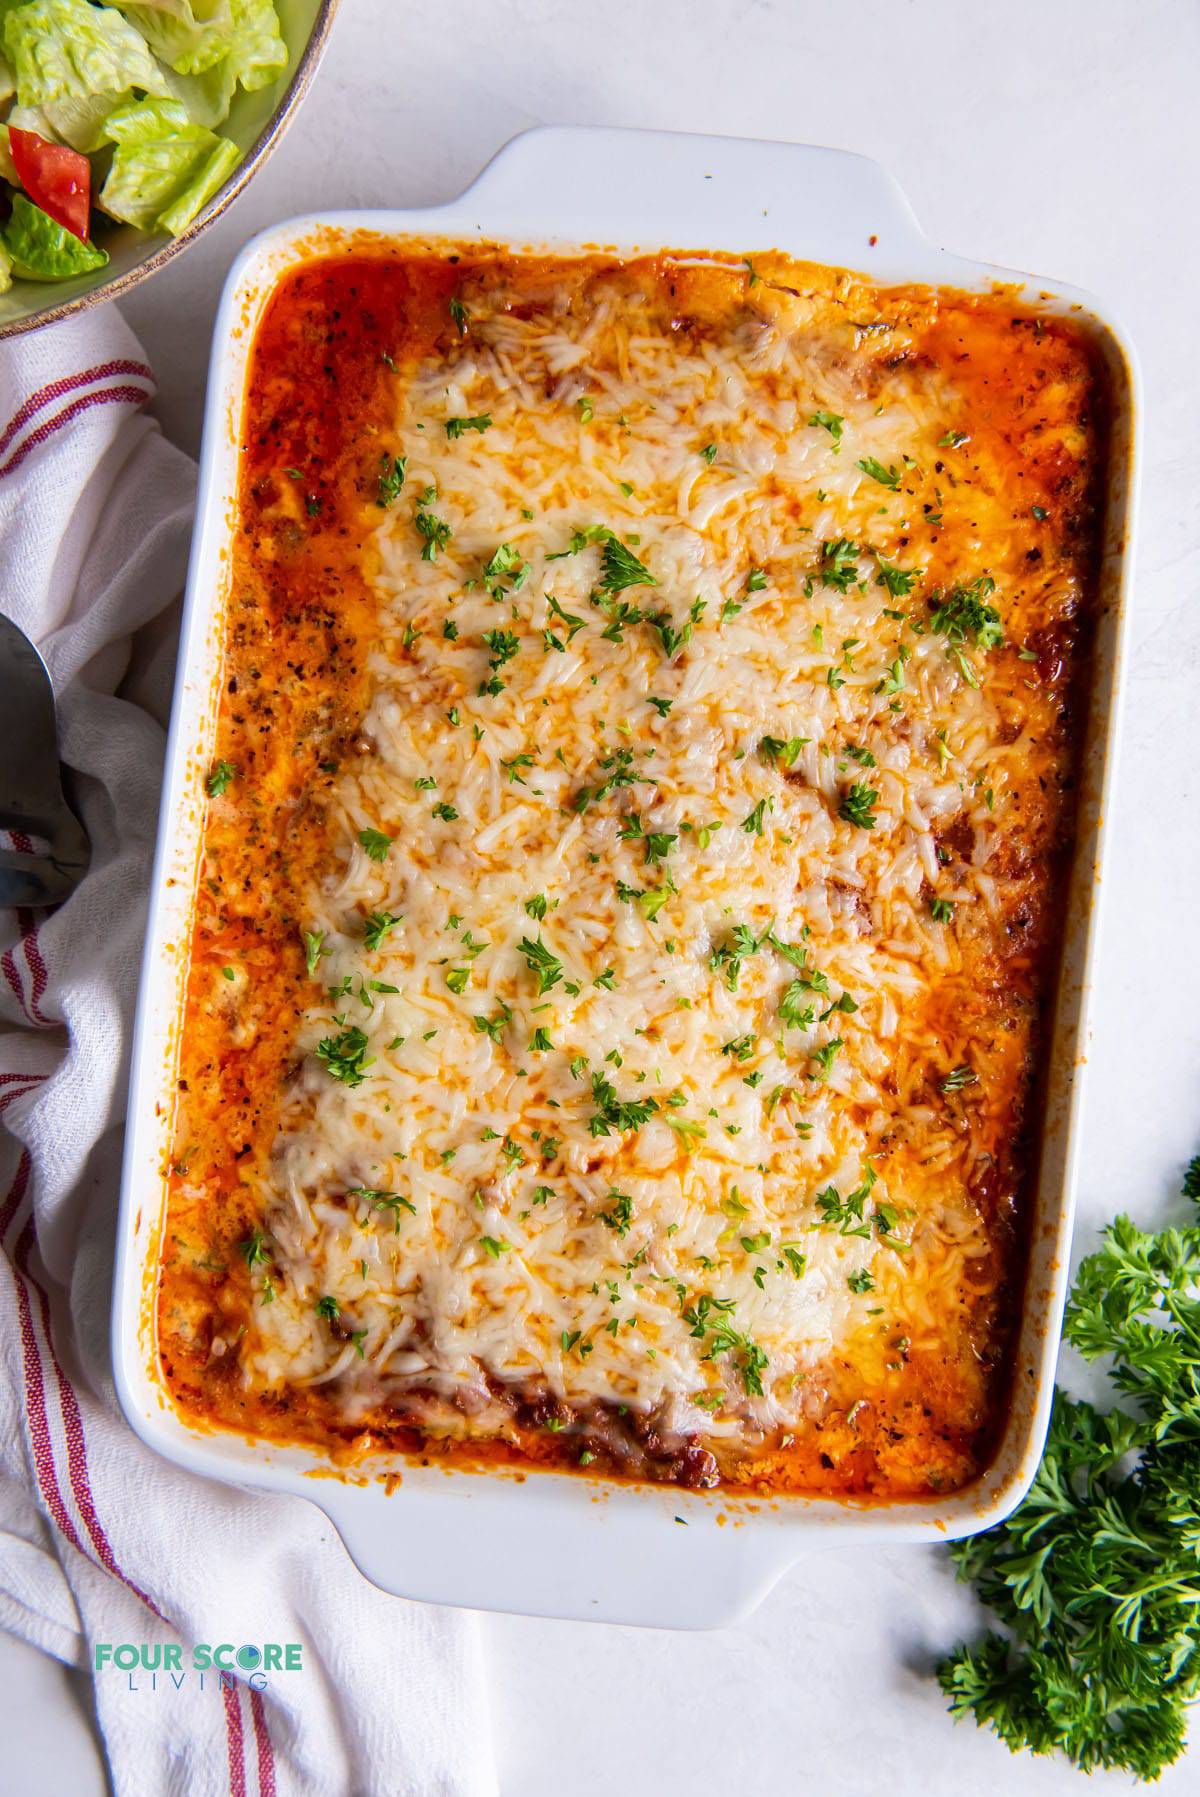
[4, 0, 167, 106]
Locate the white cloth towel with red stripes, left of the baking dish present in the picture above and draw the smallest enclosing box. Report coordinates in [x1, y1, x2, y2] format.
[0, 307, 496, 1797]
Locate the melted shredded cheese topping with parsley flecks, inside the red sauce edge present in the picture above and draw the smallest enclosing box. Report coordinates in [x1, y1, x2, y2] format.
[158, 246, 1089, 1488]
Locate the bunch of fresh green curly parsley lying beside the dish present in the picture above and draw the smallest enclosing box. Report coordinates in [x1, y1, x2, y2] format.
[938, 1155, 1200, 1779]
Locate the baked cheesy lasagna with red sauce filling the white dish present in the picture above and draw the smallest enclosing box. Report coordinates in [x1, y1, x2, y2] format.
[156, 243, 1105, 1500]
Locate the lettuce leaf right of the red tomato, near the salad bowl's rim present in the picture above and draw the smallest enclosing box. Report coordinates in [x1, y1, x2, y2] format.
[97, 101, 241, 235]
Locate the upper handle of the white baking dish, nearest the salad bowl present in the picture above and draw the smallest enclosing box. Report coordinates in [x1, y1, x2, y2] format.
[458, 126, 931, 279]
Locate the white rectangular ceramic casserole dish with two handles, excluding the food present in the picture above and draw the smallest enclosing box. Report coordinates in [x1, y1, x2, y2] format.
[113, 128, 1137, 1628]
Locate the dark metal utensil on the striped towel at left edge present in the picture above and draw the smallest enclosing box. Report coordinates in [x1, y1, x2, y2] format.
[0, 615, 92, 906]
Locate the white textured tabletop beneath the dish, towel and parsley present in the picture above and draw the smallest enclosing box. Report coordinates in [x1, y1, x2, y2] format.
[9, 0, 1200, 1797]
